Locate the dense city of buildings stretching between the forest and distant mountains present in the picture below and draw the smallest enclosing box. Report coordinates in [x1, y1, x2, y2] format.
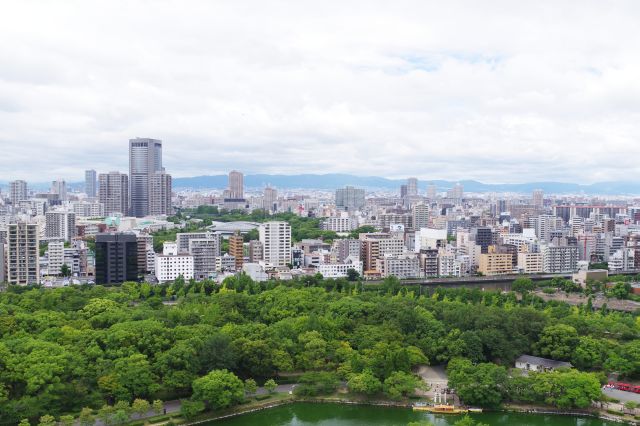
[0, 138, 640, 292]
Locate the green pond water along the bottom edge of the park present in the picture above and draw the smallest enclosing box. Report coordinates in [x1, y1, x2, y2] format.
[208, 403, 620, 426]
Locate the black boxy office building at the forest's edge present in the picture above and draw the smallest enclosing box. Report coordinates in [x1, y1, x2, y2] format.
[96, 233, 138, 284]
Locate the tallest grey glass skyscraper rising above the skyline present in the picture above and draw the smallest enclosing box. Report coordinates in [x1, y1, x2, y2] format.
[129, 138, 163, 217]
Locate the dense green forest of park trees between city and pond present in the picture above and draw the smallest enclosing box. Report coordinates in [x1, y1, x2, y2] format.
[0, 275, 640, 424]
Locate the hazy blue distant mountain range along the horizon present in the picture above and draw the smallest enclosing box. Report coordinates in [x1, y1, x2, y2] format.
[173, 173, 640, 195]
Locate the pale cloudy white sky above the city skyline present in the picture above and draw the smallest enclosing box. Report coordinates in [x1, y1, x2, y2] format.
[0, 0, 640, 183]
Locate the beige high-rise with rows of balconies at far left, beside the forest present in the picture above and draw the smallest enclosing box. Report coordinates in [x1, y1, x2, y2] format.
[7, 222, 40, 285]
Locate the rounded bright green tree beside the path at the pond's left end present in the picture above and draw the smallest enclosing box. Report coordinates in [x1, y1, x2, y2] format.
[193, 370, 244, 409]
